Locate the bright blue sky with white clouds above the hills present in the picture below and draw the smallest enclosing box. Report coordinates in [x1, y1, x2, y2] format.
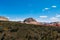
[0, 0, 60, 22]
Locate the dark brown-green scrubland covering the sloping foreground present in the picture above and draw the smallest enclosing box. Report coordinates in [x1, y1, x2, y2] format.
[0, 21, 60, 40]
